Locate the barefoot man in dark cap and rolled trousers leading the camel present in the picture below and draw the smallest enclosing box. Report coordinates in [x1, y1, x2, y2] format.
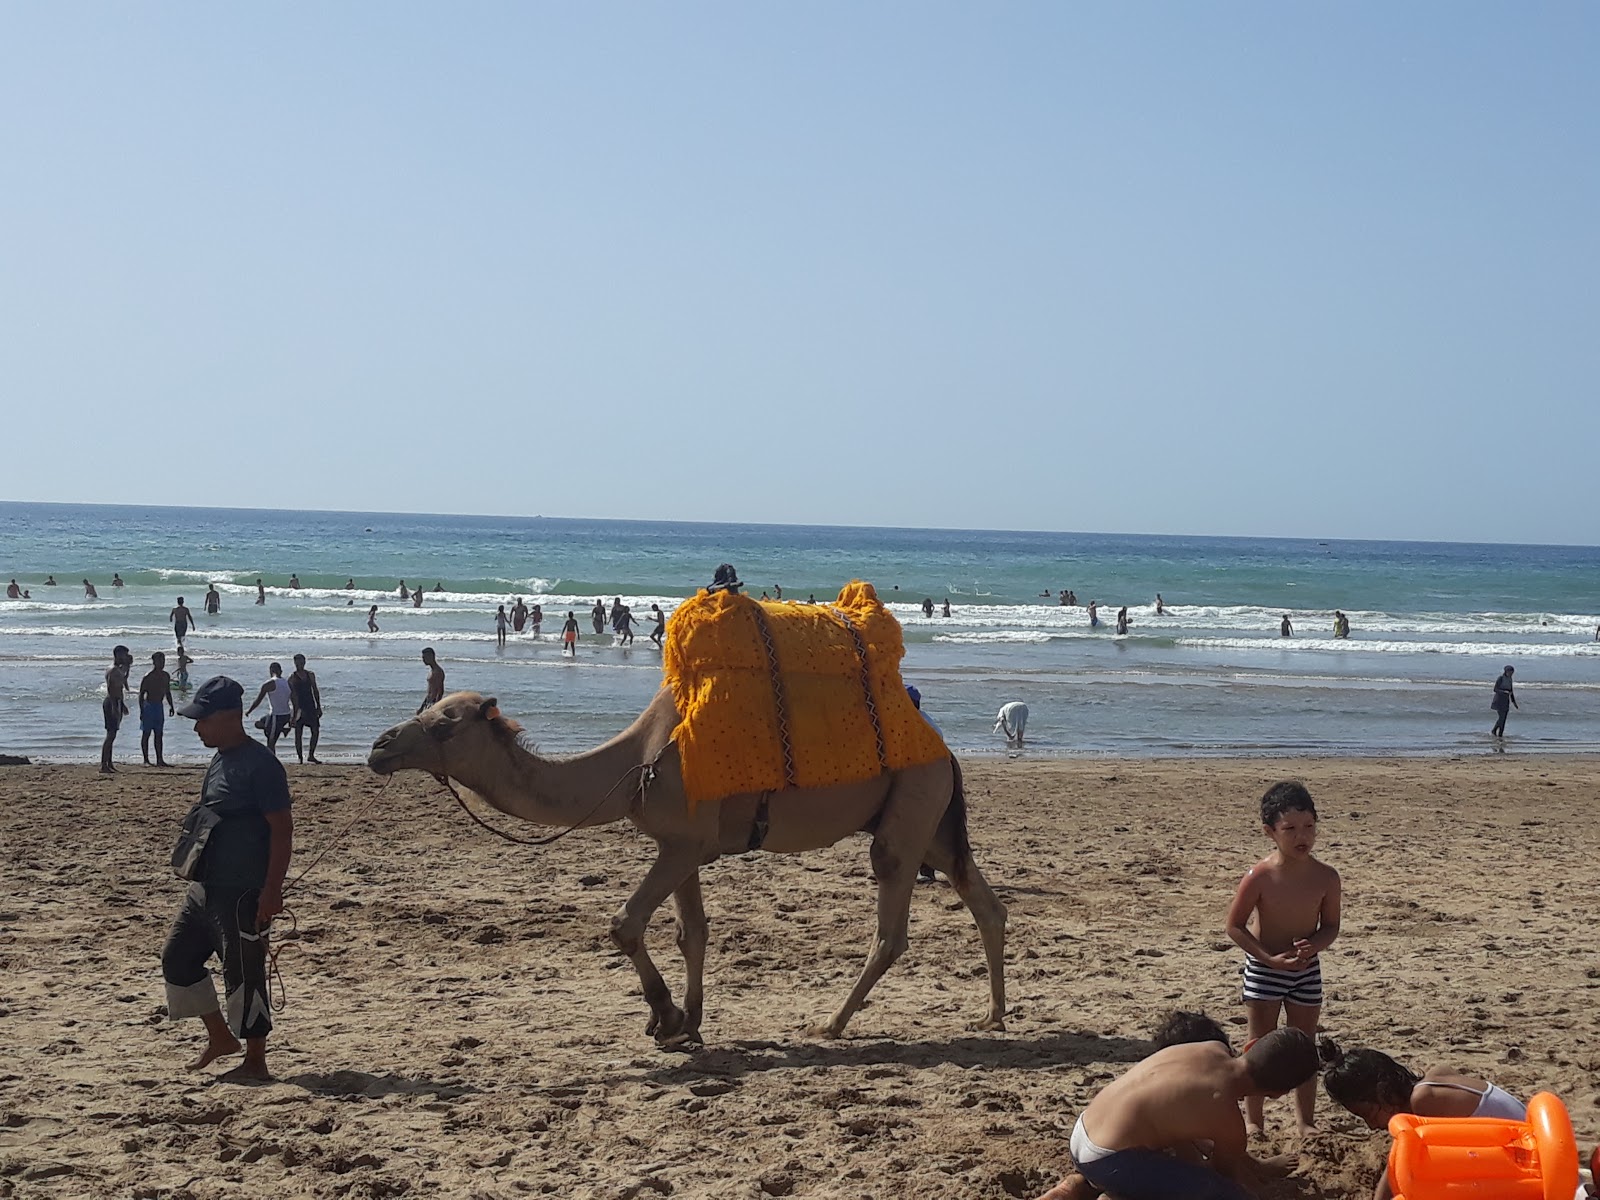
[162, 675, 294, 1080]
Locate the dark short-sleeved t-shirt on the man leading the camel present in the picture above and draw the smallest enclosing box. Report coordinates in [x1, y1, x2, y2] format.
[200, 739, 290, 888]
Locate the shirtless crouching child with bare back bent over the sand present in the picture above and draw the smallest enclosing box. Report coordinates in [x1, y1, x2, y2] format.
[1046, 1029, 1317, 1200]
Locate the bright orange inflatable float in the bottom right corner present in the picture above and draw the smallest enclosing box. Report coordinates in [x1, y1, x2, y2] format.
[1389, 1091, 1578, 1200]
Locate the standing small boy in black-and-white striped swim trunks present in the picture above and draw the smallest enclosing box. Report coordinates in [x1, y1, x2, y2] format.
[1227, 782, 1341, 1136]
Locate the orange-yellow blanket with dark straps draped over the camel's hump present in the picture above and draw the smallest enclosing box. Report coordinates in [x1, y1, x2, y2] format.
[662, 581, 950, 806]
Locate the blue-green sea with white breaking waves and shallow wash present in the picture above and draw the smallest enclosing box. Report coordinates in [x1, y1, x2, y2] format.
[0, 504, 1600, 762]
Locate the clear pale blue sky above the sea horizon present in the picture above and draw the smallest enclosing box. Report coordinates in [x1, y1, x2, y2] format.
[0, 0, 1600, 544]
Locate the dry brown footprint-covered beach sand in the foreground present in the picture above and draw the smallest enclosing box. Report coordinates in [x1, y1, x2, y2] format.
[0, 757, 1600, 1200]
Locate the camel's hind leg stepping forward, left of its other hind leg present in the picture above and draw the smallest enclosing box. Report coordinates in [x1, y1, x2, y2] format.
[818, 763, 949, 1037]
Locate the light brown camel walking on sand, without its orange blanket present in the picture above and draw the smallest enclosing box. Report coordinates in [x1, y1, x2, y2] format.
[366, 688, 1006, 1045]
